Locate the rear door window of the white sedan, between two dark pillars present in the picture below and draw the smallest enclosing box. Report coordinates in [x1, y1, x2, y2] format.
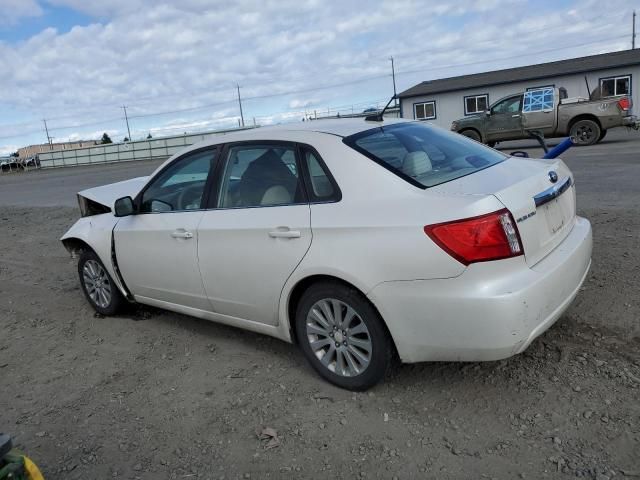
[218, 145, 307, 208]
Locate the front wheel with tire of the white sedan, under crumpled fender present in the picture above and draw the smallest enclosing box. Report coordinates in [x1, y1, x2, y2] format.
[78, 250, 126, 316]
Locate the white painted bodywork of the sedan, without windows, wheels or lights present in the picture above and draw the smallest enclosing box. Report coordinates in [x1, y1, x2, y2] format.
[63, 120, 591, 362]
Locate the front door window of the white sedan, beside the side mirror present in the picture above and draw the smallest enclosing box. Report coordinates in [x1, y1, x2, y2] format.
[140, 149, 216, 213]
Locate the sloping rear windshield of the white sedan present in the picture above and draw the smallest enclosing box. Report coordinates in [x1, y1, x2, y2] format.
[344, 122, 507, 188]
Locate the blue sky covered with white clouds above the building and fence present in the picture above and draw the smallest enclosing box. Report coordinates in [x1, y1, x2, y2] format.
[0, 0, 640, 155]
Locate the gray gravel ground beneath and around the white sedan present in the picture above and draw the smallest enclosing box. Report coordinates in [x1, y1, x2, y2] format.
[0, 132, 640, 480]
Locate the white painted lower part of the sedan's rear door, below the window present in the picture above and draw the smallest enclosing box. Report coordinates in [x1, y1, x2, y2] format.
[198, 205, 311, 325]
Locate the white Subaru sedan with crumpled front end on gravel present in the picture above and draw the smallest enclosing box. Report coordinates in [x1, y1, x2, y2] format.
[62, 119, 591, 390]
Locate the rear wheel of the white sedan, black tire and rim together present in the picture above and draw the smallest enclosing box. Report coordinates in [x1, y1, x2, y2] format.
[295, 282, 393, 391]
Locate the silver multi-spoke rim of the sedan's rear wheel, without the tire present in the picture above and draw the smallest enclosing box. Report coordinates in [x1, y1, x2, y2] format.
[306, 298, 373, 377]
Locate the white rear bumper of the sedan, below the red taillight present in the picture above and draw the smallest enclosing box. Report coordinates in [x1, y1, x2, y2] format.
[369, 217, 592, 362]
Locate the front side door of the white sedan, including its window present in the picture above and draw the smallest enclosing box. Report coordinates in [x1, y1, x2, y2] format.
[114, 148, 216, 310]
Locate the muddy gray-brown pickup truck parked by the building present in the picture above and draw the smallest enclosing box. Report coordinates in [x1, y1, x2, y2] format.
[451, 87, 638, 147]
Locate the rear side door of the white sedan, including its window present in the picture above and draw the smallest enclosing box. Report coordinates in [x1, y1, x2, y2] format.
[198, 142, 311, 325]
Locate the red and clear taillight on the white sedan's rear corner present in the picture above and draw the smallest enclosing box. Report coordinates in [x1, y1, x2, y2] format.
[424, 208, 523, 265]
